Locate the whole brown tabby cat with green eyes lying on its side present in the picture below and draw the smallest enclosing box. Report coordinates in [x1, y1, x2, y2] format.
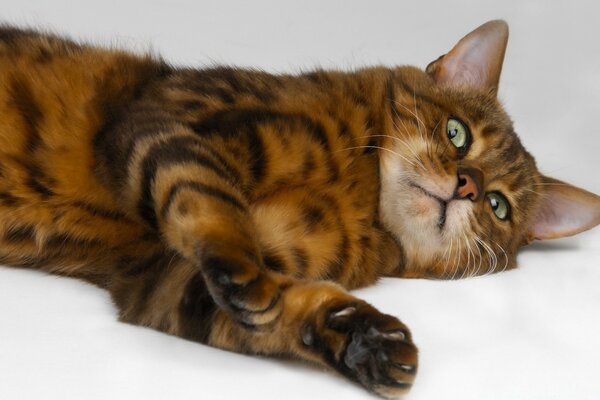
[0, 21, 600, 397]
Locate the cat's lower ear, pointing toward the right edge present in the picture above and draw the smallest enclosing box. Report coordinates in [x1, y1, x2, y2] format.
[528, 177, 600, 241]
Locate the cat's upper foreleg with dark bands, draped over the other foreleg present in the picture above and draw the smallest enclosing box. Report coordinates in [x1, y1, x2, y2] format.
[98, 125, 281, 327]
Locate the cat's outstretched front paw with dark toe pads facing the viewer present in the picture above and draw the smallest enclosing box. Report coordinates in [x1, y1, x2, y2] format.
[302, 302, 417, 398]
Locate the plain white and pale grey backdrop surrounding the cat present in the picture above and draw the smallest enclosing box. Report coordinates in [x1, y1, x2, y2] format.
[0, 0, 600, 400]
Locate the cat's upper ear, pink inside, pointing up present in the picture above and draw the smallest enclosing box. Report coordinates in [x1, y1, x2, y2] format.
[426, 20, 508, 91]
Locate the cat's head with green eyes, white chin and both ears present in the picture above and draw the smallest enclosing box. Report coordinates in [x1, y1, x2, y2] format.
[380, 21, 600, 278]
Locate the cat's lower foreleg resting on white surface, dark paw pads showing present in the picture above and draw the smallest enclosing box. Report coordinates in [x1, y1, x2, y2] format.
[110, 253, 417, 397]
